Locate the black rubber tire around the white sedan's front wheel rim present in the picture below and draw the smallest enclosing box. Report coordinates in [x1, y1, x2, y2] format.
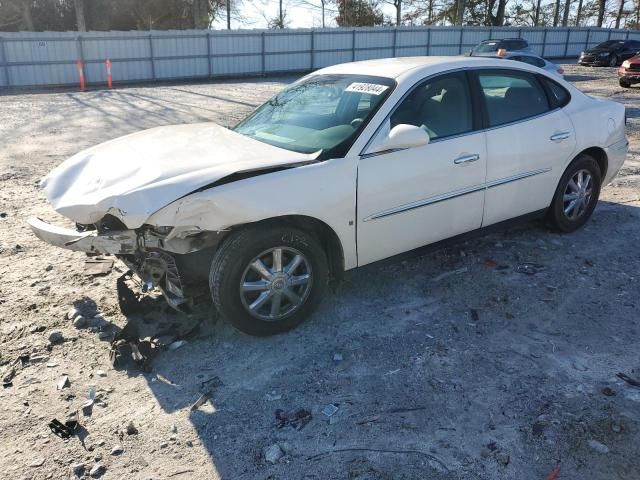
[209, 225, 329, 336]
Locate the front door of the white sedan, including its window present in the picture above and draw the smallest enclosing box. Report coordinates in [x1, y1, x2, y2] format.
[357, 72, 487, 265]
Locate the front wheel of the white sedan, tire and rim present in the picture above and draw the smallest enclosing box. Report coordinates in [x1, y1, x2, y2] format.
[209, 226, 329, 336]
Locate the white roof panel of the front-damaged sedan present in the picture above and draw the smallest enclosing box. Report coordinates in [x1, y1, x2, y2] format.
[314, 56, 527, 78]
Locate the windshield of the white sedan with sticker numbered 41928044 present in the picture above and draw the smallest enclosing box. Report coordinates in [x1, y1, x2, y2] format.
[233, 75, 395, 156]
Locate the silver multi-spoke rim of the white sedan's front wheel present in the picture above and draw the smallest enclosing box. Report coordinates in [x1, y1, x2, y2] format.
[239, 247, 313, 321]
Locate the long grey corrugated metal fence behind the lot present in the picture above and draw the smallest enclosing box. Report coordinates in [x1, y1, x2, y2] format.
[0, 26, 640, 88]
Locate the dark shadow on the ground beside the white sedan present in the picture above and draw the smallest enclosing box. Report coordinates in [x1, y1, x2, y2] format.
[106, 202, 640, 480]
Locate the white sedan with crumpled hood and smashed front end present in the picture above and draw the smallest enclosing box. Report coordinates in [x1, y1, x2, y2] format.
[29, 57, 628, 335]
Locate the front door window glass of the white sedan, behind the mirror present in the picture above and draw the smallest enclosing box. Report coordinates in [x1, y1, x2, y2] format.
[391, 73, 473, 140]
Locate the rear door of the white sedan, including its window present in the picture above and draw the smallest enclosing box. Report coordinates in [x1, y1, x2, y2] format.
[475, 69, 576, 226]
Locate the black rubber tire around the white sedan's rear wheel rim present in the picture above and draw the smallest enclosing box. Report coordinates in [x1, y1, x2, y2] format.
[547, 154, 602, 233]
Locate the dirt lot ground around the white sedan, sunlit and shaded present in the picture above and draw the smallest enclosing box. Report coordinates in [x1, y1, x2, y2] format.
[0, 65, 640, 480]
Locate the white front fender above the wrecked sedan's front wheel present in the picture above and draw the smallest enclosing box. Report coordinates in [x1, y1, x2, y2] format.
[146, 158, 357, 269]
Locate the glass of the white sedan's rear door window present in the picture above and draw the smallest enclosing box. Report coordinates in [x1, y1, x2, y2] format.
[478, 70, 549, 127]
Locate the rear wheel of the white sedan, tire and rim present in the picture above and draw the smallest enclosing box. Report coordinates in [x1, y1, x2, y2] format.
[547, 154, 602, 232]
